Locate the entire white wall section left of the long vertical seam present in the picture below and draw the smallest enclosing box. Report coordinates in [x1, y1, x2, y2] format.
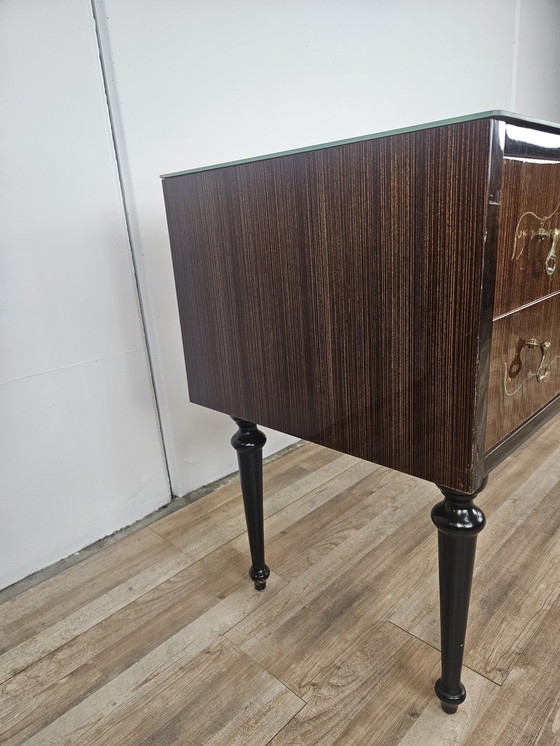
[0, 0, 169, 587]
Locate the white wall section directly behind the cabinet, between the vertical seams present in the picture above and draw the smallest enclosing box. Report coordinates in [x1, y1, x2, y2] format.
[95, 0, 540, 494]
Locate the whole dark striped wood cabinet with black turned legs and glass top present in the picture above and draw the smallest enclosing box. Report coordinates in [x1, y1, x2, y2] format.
[163, 112, 560, 712]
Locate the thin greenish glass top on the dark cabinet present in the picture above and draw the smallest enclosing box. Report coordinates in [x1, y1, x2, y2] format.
[161, 109, 560, 179]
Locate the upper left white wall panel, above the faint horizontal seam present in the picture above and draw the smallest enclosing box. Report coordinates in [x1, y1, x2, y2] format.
[0, 0, 148, 381]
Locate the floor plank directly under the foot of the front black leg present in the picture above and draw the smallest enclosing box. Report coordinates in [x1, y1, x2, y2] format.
[272, 621, 499, 746]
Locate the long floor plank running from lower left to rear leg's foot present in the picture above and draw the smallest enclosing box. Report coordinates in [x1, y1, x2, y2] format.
[0, 546, 266, 743]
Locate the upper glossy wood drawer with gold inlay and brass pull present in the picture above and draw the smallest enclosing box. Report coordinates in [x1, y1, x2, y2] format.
[494, 158, 560, 317]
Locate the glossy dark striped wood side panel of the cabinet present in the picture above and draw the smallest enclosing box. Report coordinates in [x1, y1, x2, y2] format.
[164, 120, 492, 491]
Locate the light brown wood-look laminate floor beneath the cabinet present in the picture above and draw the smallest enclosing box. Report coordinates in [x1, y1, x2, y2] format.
[0, 417, 560, 746]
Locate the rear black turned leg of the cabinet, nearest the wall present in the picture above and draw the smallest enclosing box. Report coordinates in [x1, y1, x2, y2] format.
[231, 417, 270, 591]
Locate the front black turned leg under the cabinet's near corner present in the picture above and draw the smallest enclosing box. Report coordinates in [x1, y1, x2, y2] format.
[432, 480, 486, 714]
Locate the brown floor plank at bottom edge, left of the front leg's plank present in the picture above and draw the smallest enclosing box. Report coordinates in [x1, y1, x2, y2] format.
[27, 639, 304, 746]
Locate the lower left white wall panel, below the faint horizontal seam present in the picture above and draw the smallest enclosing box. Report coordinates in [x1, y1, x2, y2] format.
[0, 350, 167, 588]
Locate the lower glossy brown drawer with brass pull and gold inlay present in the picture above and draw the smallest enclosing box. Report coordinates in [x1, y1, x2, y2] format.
[486, 294, 560, 450]
